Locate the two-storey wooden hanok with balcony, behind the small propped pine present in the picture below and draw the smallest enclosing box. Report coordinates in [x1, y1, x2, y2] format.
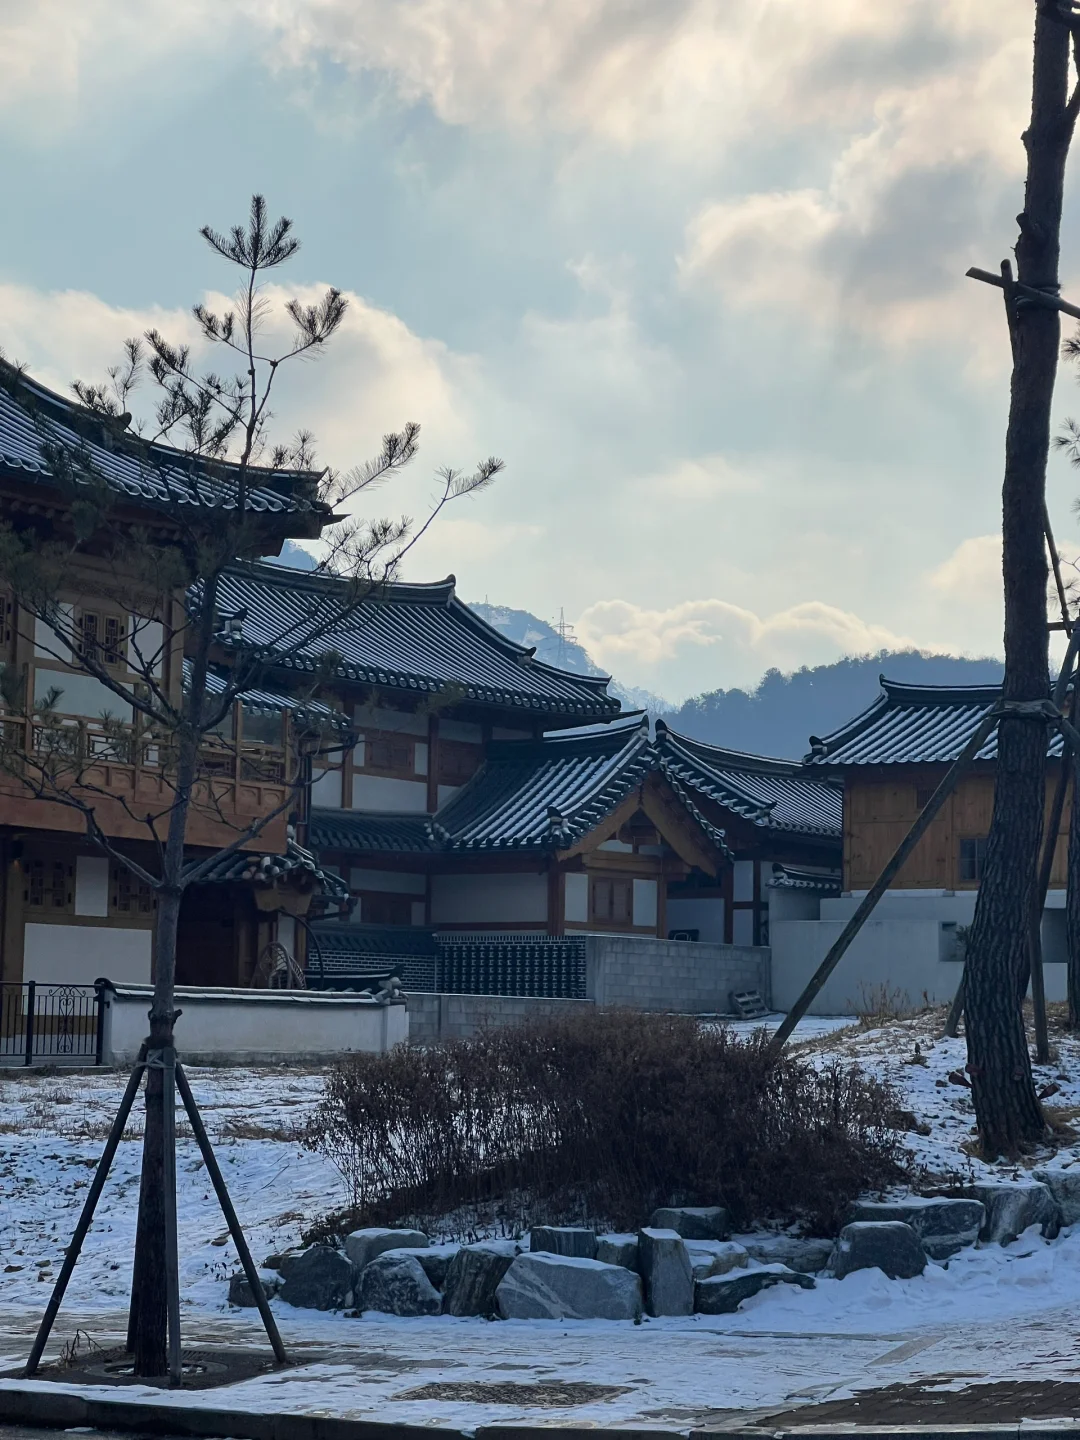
[0, 367, 342, 985]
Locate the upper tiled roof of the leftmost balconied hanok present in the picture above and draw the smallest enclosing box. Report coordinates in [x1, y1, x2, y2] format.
[0, 361, 330, 521]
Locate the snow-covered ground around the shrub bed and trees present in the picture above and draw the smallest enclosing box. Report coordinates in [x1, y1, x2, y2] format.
[0, 1012, 1080, 1427]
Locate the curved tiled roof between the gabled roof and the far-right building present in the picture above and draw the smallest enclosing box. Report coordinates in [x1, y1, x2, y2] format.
[657, 720, 844, 838]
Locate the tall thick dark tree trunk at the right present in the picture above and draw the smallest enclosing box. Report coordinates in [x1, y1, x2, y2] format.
[965, 3, 1074, 1155]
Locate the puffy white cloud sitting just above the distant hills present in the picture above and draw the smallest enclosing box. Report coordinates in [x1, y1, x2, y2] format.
[575, 599, 914, 696]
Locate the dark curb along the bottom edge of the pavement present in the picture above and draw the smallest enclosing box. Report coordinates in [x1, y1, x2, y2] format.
[0, 1385, 1080, 1440]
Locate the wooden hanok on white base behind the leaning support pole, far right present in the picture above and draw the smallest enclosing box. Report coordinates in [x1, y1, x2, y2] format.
[770, 677, 1070, 1014]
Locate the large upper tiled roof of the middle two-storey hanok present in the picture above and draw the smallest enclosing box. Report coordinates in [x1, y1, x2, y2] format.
[211, 564, 619, 720]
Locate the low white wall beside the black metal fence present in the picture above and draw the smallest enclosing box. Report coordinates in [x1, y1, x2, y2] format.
[102, 982, 409, 1066]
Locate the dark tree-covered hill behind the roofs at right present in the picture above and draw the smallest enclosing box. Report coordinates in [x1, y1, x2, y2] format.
[664, 649, 1002, 760]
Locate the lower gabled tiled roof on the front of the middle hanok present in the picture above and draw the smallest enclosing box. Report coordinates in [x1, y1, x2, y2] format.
[308, 716, 726, 852]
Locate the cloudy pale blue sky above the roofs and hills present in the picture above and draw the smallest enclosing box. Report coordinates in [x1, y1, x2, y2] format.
[0, 0, 1080, 698]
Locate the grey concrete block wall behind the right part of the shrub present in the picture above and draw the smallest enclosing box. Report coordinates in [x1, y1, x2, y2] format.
[585, 935, 770, 1015]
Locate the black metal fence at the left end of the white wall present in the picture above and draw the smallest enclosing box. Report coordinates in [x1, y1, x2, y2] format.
[0, 981, 104, 1066]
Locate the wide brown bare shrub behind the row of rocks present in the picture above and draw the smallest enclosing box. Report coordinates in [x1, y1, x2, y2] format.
[304, 1011, 906, 1227]
